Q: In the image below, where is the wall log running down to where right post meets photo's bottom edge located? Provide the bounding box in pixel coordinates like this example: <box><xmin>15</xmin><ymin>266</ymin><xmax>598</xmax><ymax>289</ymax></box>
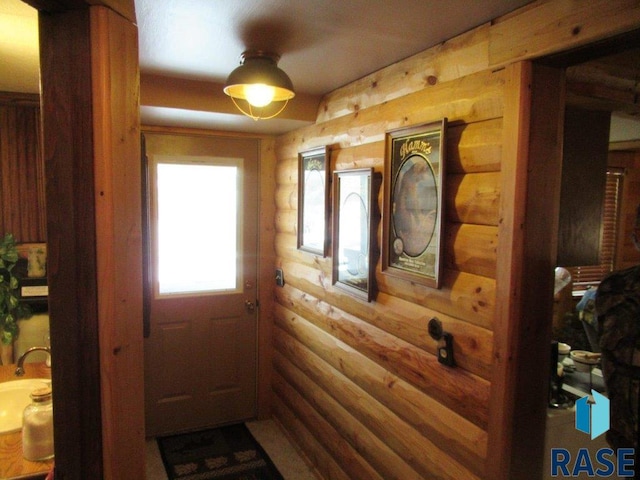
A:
<box><xmin>274</xmin><ymin>344</ymin><xmax>477</xmax><ymax>480</ymax></box>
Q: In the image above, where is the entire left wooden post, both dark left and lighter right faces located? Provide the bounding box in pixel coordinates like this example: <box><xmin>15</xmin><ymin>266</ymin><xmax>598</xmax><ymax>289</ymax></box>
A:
<box><xmin>39</xmin><ymin>2</ymin><xmax>145</xmax><ymax>479</ymax></box>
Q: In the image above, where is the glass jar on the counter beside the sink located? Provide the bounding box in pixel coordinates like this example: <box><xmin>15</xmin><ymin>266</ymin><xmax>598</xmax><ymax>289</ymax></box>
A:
<box><xmin>22</xmin><ymin>387</ymin><xmax>53</xmax><ymax>462</ymax></box>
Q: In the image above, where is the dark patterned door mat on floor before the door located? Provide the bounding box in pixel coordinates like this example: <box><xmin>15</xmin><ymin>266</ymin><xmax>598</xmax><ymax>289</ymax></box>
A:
<box><xmin>157</xmin><ymin>424</ymin><xmax>284</xmax><ymax>480</ymax></box>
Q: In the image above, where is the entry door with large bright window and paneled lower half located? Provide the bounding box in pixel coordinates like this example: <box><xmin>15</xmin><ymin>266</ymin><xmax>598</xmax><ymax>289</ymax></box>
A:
<box><xmin>144</xmin><ymin>133</ymin><xmax>259</xmax><ymax>436</ymax></box>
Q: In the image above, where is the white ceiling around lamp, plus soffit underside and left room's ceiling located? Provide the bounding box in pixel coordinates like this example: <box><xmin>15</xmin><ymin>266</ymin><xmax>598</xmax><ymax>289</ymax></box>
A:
<box><xmin>0</xmin><ymin>0</ymin><xmax>531</xmax><ymax>133</ymax></box>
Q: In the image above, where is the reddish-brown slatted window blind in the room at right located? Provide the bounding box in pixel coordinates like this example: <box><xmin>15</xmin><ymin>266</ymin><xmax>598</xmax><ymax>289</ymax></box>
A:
<box><xmin>567</xmin><ymin>167</ymin><xmax>624</xmax><ymax>293</ymax></box>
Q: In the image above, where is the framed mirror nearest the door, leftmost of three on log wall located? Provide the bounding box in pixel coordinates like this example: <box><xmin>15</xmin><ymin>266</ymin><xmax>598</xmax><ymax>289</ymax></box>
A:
<box><xmin>298</xmin><ymin>147</ymin><xmax>331</xmax><ymax>257</ymax></box>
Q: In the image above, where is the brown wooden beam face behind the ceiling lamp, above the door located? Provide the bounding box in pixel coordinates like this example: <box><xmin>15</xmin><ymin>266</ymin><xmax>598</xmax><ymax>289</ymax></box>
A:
<box><xmin>140</xmin><ymin>73</ymin><xmax>321</xmax><ymax>122</ymax></box>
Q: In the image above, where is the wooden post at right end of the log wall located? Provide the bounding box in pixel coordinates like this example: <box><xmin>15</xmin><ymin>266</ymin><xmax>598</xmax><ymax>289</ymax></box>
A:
<box><xmin>485</xmin><ymin>62</ymin><xmax>564</xmax><ymax>480</ymax></box>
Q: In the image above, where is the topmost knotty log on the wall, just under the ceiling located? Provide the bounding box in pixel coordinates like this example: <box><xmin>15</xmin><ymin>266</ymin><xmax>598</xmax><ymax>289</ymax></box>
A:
<box><xmin>317</xmin><ymin>25</ymin><xmax>488</xmax><ymax>123</ymax></box>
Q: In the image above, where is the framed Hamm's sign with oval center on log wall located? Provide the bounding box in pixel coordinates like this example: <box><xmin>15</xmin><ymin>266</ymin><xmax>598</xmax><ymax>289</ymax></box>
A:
<box><xmin>382</xmin><ymin>118</ymin><xmax>447</xmax><ymax>288</ymax></box>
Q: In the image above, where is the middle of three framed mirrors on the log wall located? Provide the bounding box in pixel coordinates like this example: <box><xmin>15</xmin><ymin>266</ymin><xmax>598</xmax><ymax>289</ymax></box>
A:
<box><xmin>332</xmin><ymin>168</ymin><xmax>379</xmax><ymax>302</ymax></box>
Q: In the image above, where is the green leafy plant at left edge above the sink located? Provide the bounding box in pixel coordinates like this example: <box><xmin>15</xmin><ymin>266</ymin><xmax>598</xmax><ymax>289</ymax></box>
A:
<box><xmin>0</xmin><ymin>233</ymin><xmax>31</xmax><ymax>364</ymax></box>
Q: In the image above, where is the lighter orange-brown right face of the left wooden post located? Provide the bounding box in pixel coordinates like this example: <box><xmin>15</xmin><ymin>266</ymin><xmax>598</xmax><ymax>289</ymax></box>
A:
<box><xmin>90</xmin><ymin>2</ymin><xmax>145</xmax><ymax>480</ymax></box>
